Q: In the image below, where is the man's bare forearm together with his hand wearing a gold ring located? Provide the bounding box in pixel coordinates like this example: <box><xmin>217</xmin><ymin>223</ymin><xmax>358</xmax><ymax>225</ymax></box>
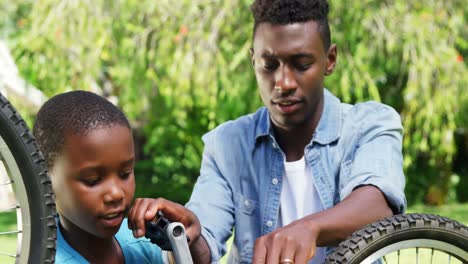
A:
<box><xmin>252</xmin><ymin>185</ymin><xmax>392</xmax><ymax>264</ymax></box>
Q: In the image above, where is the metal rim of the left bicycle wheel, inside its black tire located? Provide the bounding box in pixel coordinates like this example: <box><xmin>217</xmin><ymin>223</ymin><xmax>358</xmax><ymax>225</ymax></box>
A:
<box><xmin>0</xmin><ymin>136</ymin><xmax>31</xmax><ymax>263</ymax></box>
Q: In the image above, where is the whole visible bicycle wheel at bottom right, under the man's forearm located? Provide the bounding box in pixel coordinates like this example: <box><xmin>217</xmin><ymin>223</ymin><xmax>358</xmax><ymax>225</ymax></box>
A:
<box><xmin>326</xmin><ymin>214</ymin><xmax>468</xmax><ymax>264</ymax></box>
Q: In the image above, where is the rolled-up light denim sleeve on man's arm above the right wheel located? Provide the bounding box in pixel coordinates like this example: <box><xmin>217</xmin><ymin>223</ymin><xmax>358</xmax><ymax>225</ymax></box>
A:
<box><xmin>340</xmin><ymin>103</ymin><xmax>406</xmax><ymax>214</ymax></box>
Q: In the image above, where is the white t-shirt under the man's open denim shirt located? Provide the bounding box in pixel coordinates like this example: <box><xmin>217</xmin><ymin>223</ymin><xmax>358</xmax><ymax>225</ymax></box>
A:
<box><xmin>279</xmin><ymin>157</ymin><xmax>326</xmax><ymax>264</ymax></box>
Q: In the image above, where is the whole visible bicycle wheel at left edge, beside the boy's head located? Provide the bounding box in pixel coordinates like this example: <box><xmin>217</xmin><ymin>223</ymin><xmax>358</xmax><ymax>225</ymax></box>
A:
<box><xmin>0</xmin><ymin>93</ymin><xmax>56</xmax><ymax>263</ymax></box>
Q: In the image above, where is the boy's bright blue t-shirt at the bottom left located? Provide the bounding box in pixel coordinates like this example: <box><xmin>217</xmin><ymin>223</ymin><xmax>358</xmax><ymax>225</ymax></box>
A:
<box><xmin>55</xmin><ymin>219</ymin><xmax>164</xmax><ymax>264</ymax></box>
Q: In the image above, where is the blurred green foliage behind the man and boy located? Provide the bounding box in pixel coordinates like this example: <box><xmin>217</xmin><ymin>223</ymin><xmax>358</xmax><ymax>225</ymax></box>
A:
<box><xmin>0</xmin><ymin>0</ymin><xmax>468</xmax><ymax>205</ymax></box>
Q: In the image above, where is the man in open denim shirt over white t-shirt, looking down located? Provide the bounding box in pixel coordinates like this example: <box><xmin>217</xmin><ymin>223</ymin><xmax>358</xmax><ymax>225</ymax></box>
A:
<box><xmin>129</xmin><ymin>0</ymin><xmax>406</xmax><ymax>264</ymax></box>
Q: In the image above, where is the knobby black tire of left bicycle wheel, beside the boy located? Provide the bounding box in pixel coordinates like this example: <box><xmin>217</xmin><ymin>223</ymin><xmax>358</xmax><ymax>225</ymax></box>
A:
<box><xmin>0</xmin><ymin>93</ymin><xmax>57</xmax><ymax>263</ymax></box>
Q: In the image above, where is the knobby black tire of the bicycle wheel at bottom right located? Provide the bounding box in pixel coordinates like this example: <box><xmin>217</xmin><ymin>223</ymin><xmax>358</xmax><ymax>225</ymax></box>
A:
<box><xmin>325</xmin><ymin>213</ymin><xmax>468</xmax><ymax>264</ymax></box>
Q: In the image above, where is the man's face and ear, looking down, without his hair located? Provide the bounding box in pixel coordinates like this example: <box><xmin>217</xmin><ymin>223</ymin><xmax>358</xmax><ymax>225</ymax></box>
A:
<box><xmin>251</xmin><ymin>21</ymin><xmax>336</xmax><ymax>129</ymax></box>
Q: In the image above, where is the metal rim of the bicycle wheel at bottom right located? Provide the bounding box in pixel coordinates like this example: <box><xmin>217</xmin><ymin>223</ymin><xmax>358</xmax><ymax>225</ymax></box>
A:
<box><xmin>361</xmin><ymin>239</ymin><xmax>468</xmax><ymax>264</ymax></box>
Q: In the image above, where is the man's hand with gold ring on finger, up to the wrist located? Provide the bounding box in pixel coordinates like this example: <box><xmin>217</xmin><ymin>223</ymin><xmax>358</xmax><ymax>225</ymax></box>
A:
<box><xmin>252</xmin><ymin>218</ymin><xmax>319</xmax><ymax>264</ymax></box>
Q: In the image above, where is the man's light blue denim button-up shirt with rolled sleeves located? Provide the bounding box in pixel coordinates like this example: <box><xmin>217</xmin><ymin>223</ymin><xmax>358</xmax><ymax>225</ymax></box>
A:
<box><xmin>187</xmin><ymin>90</ymin><xmax>406</xmax><ymax>263</ymax></box>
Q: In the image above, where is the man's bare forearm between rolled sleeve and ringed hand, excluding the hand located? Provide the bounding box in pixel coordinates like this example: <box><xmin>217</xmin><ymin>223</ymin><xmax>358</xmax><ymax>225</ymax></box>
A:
<box><xmin>305</xmin><ymin>186</ymin><xmax>393</xmax><ymax>246</ymax></box>
